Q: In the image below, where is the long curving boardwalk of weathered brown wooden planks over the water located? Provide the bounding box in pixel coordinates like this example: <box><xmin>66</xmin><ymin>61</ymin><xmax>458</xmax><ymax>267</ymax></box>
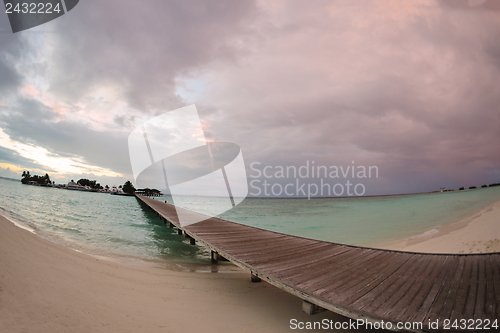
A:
<box><xmin>137</xmin><ymin>196</ymin><xmax>500</xmax><ymax>332</ymax></box>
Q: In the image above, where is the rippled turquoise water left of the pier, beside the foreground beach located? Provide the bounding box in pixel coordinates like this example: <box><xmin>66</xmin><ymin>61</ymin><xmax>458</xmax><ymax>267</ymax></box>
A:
<box><xmin>0</xmin><ymin>178</ymin><xmax>210</xmax><ymax>264</ymax></box>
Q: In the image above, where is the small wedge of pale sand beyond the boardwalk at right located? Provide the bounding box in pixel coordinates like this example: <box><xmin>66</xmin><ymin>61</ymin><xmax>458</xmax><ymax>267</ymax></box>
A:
<box><xmin>380</xmin><ymin>197</ymin><xmax>500</xmax><ymax>254</ymax></box>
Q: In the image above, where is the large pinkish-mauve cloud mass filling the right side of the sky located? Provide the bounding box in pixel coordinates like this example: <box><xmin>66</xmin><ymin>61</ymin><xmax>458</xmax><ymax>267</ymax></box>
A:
<box><xmin>194</xmin><ymin>2</ymin><xmax>500</xmax><ymax>190</ymax></box>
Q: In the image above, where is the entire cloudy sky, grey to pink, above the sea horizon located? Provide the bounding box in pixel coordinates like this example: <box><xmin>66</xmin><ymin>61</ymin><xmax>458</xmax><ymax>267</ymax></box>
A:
<box><xmin>0</xmin><ymin>0</ymin><xmax>500</xmax><ymax>194</ymax></box>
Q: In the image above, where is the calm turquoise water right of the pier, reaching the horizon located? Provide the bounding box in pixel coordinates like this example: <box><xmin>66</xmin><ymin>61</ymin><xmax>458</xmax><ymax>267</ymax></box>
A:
<box><xmin>170</xmin><ymin>187</ymin><xmax>500</xmax><ymax>247</ymax></box>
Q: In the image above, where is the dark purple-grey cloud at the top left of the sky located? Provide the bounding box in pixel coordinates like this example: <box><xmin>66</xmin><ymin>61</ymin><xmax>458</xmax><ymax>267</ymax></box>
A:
<box><xmin>46</xmin><ymin>0</ymin><xmax>256</xmax><ymax>111</ymax></box>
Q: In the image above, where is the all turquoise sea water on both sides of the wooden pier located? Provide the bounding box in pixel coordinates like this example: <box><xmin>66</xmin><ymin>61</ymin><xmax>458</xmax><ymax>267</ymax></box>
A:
<box><xmin>0</xmin><ymin>178</ymin><xmax>500</xmax><ymax>263</ymax></box>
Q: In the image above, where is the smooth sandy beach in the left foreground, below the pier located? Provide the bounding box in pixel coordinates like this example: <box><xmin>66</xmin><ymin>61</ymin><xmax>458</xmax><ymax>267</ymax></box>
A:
<box><xmin>0</xmin><ymin>216</ymin><xmax>348</xmax><ymax>333</ymax></box>
